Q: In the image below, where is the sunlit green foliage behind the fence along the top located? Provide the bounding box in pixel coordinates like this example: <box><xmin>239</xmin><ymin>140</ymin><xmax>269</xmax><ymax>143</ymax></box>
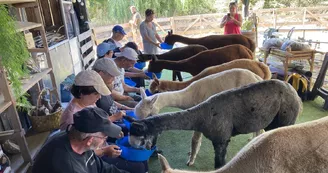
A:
<box><xmin>87</xmin><ymin>0</ymin><xmax>328</xmax><ymax>25</ymax></box>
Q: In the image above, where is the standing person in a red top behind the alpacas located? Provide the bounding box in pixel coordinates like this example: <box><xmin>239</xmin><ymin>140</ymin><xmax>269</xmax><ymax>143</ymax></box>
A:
<box><xmin>220</xmin><ymin>2</ymin><xmax>243</xmax><ymax>35</ymax></box>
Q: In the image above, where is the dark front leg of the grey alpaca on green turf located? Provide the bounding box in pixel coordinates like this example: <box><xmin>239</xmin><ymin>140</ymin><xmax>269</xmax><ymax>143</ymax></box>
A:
<box><xmin>212</xmin><ymin>140</ymin><xmax>229</xmax><ymax>169</ymax></box>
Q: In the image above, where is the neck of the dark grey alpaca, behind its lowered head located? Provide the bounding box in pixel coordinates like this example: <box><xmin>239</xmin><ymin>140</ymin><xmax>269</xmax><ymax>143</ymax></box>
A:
<box><xmin>140</xmin><ymin>110</ymin><xmax>200</xmax><ymax>135</ymax></box>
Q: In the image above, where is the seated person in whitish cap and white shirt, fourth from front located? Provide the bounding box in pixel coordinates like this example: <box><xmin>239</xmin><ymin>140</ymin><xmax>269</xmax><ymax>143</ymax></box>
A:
<box><xmin>112</xmin><ymin>47</ymin><xmax>146</xmax><ymax>108</ymax></box>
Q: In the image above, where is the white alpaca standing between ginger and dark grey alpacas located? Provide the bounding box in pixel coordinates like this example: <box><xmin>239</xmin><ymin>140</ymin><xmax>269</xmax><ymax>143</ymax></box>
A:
<box><xmin>135</xmin><ymin>68</ymin><xmax>263</xmax><ymax>166</ymax></box>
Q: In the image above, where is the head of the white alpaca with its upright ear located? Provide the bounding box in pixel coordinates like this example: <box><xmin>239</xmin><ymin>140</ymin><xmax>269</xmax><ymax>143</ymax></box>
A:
<box><xmin>134</xmin><ymin>88</ymin><xmax>158</xmax><ymax>119</ymax></box>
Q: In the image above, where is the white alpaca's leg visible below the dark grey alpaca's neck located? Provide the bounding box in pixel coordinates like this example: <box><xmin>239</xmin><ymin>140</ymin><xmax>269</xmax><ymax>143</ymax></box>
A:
<box><xmin>187</xmin><ymin>131</ymin><xmax>203</xmax><ymax>166</ymax></box>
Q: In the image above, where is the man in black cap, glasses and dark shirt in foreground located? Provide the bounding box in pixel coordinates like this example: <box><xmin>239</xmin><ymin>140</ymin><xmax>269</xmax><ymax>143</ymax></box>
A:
<box><xmin>32</xmin><ymin>107</ymin><xmax>127</xmax><ymax>173</ymax></box>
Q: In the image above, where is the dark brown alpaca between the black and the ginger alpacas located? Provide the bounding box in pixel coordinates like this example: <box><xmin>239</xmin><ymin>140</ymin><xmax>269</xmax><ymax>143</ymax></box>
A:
<box><xmin>148</xmin><ymin>44</ymin><xmax>253</xmax><ymax>76</ymax></box>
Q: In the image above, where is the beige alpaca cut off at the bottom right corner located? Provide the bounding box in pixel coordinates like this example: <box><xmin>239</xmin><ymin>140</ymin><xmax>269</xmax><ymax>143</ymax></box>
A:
<box><xmin>159</xmin><ymin>117</ymin><xmax>328</xmax><ymax>173</ymax></box>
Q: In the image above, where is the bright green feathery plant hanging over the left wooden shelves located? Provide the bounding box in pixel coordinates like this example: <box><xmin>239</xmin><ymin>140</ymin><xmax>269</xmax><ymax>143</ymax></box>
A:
<box><xmin>0</xmin><ymin>5</ymin><xmax>30</xmax><ymax>104</ymax></box>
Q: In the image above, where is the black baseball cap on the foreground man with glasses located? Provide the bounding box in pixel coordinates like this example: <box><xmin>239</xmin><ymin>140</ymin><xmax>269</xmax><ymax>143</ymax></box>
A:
<box><xmin>73</xmin><ymin>107</ymin><xmax>122</xmax><ymax>138</ymax></box>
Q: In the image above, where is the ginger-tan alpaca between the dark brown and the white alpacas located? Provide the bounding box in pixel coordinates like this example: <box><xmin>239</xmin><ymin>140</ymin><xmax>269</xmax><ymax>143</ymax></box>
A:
<box><xmin>149</xmin><ymin>59</ymin><xmax>271</xmax><ymax>93</ymax></box>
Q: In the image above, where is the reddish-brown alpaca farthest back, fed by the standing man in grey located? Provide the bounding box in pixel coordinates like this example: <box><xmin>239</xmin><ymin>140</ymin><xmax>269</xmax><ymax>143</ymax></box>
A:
<box><xmin>164</xmin><ymin>32</ymin><xmax>256</xmax><ymax>52</ymax></box>
